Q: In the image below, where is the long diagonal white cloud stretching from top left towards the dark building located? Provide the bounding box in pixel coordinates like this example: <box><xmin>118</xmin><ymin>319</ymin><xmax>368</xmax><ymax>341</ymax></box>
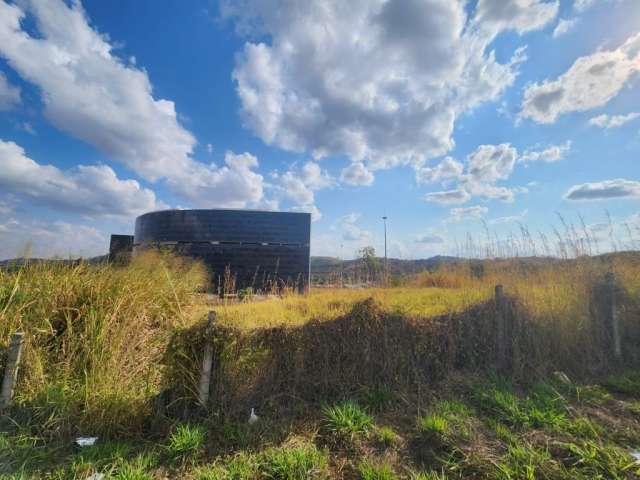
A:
<box><xmin>0</xmin><ymin>0</ymin><xmax>262</xmax><ymax>207</ymax></box>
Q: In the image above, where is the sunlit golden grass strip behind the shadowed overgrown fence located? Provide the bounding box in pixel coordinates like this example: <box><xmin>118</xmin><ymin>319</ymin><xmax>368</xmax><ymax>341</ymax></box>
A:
<box><xmin>210</xmin><ymin>256</ymin><xmax>640</xmax><ymax>329</ymax></box>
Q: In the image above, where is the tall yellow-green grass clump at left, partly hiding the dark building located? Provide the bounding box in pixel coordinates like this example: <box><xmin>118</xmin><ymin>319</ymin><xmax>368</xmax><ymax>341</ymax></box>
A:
<box><xmin>0</xmin><ymin>252</ymin><xmax>206</xmax><ymax>434</ymax></box>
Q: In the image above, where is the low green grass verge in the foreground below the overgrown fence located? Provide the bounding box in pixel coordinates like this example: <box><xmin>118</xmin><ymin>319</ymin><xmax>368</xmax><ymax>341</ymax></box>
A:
<box><xmin>0</xmin><ymin>371</ymin><xmax>640</xmax><ymax>480</ymax></box>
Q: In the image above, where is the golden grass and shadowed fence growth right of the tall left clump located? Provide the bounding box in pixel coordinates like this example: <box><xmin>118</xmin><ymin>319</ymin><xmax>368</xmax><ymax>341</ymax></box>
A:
<box><xmin>165</xmin><ymin>254</ymin><xmax>640</xmax><ymax>411</ymax></box>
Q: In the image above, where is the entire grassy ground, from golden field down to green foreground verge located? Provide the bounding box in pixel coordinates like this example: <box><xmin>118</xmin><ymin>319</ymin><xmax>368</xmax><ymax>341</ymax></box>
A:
<box><xmin>0</xmin><ymin>254</ymin><xmax>640</xmax><ymax>480</ymax></box>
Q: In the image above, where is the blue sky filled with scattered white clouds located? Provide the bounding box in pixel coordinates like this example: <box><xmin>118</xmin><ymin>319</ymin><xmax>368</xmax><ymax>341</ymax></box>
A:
<box><xmin>0</xmin><ymin>0</ymin><xmax>640</xmax><ymax>258</ymax></box>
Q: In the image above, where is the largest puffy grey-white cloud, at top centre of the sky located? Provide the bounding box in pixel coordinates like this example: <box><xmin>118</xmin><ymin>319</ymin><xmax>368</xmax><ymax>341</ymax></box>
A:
<box><xmin>228</xmin><ymin>0</ymin><xmax>557</xmax><ymax>171</ymax></box>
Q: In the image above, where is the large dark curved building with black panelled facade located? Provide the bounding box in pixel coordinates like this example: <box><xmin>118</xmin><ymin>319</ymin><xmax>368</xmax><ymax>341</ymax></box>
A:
<box><xmin>133</xmin><ymin>210</ymin><xmax>311</xmax><ymax>290</ymax></box>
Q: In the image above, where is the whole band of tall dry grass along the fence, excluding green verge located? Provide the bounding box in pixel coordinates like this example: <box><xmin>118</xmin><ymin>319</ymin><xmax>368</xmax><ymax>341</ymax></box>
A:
<box><xmin>0</xmin><ymin>242</ymin><xmax>640</xmax><ymax>435</ymax></box>
